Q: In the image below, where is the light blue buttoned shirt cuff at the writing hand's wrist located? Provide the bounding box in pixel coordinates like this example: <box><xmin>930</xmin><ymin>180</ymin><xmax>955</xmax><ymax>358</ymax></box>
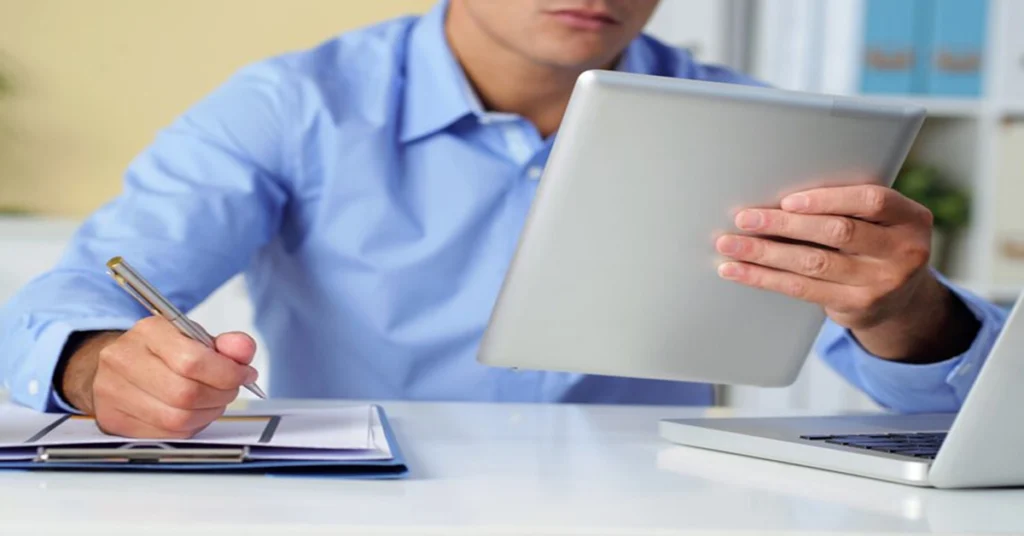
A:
<box><xmin>6</xmin><ymin>317</ymin><xmax>138</xmax><ymax>413</ymax></box>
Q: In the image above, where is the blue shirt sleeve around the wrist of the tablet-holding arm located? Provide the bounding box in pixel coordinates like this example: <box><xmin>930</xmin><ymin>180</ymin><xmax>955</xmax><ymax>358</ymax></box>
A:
<box><xmin>815</xmin><ymin>273</ymin><xmax>1008</xmax><ymax>413</ymax></box>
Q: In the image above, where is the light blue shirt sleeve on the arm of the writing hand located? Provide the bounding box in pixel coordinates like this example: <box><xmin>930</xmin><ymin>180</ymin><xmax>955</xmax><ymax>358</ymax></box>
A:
<box><xmin>0</xmin><ymin>61</ymin><xmax>295</xmax><ymax>411</ymax></box>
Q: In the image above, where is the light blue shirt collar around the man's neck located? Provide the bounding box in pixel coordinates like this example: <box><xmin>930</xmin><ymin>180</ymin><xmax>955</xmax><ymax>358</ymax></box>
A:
<box><xmin>399</xmin><ymin>0</ymin><xmax>653</xmax><ymax>143</ymax></box>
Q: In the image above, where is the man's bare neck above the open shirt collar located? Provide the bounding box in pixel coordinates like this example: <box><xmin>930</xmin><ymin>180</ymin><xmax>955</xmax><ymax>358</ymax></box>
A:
<box><xmin>444</xmin><ymin>2</ymin><xmax>602</xmax><ymax>137</ymax></box>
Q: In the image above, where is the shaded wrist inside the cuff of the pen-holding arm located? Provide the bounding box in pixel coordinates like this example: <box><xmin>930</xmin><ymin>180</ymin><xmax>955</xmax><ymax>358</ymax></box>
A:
<box><xmin>53</xmin><ymin>331</ymin><xmax>121</xmax><ymax>414</ymax></box>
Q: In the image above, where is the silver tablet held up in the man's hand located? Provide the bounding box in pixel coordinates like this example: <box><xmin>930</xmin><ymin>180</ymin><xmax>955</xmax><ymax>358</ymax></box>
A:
<box><xmin>477</xmin><ymin>71</ymin><xmax>926</xmax><ymax>386</ymax></box>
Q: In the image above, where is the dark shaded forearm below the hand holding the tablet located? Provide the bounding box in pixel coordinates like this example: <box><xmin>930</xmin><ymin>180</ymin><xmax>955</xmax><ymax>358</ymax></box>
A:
<box><xmin>853</xmin><ymin>278</ymin><xmax>981</xmax><ymax>365</ymax></box>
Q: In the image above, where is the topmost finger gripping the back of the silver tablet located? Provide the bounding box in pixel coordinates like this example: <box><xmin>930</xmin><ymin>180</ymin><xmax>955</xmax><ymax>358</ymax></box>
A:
<box><xmin>781</xmin><ymin>184</ymin><xmax>931</xmax><ymax>224</ymax></box>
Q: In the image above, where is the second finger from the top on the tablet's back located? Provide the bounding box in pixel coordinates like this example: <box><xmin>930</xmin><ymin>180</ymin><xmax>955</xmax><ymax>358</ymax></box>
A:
<box><xmin>735</xmin><ymin>209</ymin><xmax>892</xmax><ymax>256</ymax></box>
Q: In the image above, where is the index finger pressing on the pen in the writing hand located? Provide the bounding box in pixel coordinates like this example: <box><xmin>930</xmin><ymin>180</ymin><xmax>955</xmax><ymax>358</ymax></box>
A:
<box><xmin>135</xmin><ymin>317</ymin><xmax>257</xmax><ymax>390</ymax></box>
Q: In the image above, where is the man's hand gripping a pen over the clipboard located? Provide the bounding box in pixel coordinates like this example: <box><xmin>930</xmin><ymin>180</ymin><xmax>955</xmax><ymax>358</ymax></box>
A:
<box><xmin>60</xmin><ymin>317</ymin><xmax>257</xmax><ymax>439</ymax></box>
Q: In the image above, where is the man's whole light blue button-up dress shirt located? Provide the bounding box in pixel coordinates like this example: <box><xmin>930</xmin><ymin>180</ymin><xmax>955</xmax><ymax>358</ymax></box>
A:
<box><xmin>0</xmin><ymin>3</ymin><xmax>1004</xmax><ymax>411</ymax></box>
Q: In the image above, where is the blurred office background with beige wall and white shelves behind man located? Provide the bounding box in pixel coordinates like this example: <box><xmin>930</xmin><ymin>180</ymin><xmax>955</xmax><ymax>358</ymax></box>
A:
<box><xmin>0</xmin><ymin>0</ymin><xmax>1024</xmax><ymax>411</ymax></box>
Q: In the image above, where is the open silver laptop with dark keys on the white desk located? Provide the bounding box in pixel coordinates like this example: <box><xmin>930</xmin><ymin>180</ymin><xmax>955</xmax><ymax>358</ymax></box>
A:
<box><xmin>660</xmin><ymin>295</ymin><xmax>1024</xmax><ymax>488</ymax></box>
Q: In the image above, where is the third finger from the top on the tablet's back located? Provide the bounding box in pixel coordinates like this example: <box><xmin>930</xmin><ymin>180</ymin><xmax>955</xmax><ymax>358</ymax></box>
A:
<box><xmin>715</xmin><ymin>235</ymin><xmax>871</xmax><ymax>285</ymax></box>
